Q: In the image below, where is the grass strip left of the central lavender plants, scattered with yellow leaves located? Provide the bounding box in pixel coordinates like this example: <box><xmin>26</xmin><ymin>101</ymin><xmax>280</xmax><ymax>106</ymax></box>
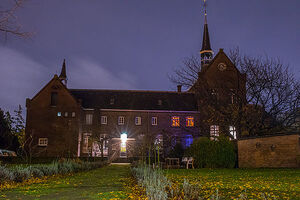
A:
<box><xmin>0</xmin><ymin>166</ymin><xmax>131</xmax><ymax>200</ymax></box>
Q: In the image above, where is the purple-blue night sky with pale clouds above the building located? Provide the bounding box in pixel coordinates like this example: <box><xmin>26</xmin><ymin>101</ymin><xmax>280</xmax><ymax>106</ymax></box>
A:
<box><xmin>0</xmin><ymin>0</ymin><xmax>300</xmax><ymax>110</ymax></box>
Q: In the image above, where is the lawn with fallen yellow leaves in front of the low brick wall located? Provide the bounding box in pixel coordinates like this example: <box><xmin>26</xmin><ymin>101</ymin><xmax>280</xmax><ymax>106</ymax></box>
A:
<box><xmin>164</xmin><ymin>169</ymin><xmax>300</xmax><ymax>199</ymax></box>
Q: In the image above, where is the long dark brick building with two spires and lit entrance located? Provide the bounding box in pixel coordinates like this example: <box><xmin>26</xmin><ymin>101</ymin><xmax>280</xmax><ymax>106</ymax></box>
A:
<box><xmin>26</xmin><ymin>10</ymin><xmax>245</xmax><ymax>160</ymax></box>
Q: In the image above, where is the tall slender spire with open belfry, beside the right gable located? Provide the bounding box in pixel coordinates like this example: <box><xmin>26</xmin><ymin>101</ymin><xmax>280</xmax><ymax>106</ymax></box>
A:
<box><xmin>200</xmin><ymin>0</ymin><xmax>214</xmax><ymax>70</ymax></box>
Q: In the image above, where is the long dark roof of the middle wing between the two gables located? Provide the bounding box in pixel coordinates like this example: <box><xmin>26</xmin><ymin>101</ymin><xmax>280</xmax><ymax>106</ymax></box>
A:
<box><xmin>69</xmin><ymin>89</ymin><xmax>197</xmax><ymax>111</ymax></box>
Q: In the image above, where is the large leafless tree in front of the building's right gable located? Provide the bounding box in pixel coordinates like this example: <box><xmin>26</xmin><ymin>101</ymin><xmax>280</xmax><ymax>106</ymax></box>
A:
<box><xmin>170</xmin><ymin>48</ymin><xmax>300</xmax><ymax>135</ymax></box>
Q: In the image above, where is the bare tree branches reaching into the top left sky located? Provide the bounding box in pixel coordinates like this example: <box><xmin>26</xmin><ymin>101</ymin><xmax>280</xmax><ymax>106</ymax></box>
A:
<box><xmin>0</xmin><ymin>0</ymin><xmax>31</xmax><ymax>38</ymax></box>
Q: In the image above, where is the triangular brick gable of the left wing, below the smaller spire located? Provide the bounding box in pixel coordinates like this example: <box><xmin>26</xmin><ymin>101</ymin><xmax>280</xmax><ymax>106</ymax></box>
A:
<box><xmin>30</xmin><ymin>75</ymin><xmax>77</xmax><ymax>108</ymax></box>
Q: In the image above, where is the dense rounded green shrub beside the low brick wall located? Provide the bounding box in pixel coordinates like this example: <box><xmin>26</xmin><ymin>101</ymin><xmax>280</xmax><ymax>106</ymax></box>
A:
<box><xmin>186</xmin><ymin>137</ymin><xmax>236</xmax><ymax>168</ymax></box>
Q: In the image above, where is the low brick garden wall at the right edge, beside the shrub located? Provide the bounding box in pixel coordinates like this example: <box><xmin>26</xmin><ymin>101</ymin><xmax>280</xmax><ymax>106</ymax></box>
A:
<box><xmin>238</xmin><ymin>134</ymin><xmax>300</xmax><ymax>168</ymax></box>
